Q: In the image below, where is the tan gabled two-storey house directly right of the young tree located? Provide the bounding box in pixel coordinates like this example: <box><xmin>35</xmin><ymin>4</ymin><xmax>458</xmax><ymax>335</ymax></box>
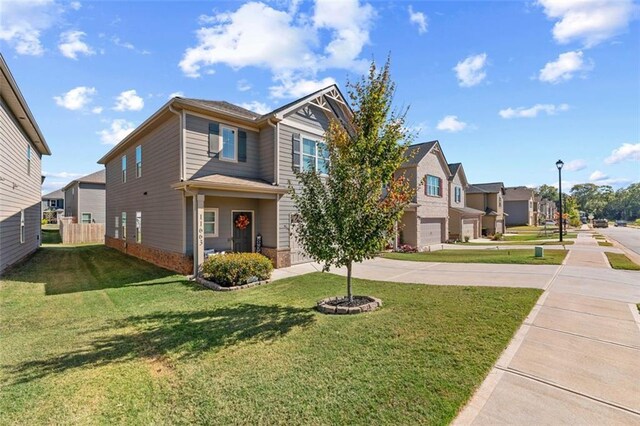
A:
<box><xmin>396</xmin><ymin>141</ymin><xmax>451</xmax><ymax>246</ymax></box>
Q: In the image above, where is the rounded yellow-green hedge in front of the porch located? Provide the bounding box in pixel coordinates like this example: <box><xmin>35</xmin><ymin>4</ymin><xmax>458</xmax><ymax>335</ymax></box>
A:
<box><xmin>202</xmin><ymin>253</ymin><xmax>273</xmax><ymax>287</ymax></box>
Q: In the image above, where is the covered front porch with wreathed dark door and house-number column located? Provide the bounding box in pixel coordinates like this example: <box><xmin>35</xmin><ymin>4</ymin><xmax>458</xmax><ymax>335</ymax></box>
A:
<box><xmin>175</xmin><ymin>175</ymin><xmax>287</xmax><ymax>273</ymax></box>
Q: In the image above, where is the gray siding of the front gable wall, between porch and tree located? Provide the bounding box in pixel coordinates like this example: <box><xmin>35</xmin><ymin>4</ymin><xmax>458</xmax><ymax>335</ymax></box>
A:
<box><xmin>278</xmin><ymin>107</ymin><xmax>329</xmax><ymax>248</ymax></box>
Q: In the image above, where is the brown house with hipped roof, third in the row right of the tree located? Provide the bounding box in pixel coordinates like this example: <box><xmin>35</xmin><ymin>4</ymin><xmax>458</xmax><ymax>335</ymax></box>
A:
<box><xmin>466</xmin><ymin>182</ymin><xmax>505</xmax><ymax>235</ymax></box>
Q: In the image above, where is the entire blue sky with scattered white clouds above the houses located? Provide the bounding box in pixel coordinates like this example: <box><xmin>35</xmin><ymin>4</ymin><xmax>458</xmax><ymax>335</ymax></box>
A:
<box><xmin>0</xmin><ymin>0</ymin><xmax>640</xmax><ymax>193</ymax></box>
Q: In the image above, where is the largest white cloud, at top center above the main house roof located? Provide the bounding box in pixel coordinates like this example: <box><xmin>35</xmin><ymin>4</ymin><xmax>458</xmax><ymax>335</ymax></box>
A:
<box><xmin>179</xmin><ymin>0</ymin><xmax>375</xmax><ymax>97</ymax></box>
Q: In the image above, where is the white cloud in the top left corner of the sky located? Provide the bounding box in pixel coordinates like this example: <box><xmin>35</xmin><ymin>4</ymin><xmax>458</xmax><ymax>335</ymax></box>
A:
<box><xmin>0</xmin><ymin>0</ymin><xmax>62</xmax><ymax>56</ymax></box>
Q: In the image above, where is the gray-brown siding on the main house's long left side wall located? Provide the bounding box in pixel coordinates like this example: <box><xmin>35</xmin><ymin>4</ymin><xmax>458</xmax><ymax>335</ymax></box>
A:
<box><xmin>106</xmin><ymin>114</ymin><xmax>185</xmax><ymax>253</ymax></box>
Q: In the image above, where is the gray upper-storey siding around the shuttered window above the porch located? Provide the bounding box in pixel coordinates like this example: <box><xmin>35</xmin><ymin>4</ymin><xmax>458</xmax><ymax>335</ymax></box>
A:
<box><xmin>185</xmin><ymin>114</ymin><xmax>261</xmax><ymax>179</ymax></box>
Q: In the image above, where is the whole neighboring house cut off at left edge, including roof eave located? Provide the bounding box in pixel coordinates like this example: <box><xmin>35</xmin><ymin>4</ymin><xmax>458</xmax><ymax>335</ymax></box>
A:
<box><xmin>0</xmin><ymin>55</ymin><xmax>51</xmax><ymax>274</ymax></box>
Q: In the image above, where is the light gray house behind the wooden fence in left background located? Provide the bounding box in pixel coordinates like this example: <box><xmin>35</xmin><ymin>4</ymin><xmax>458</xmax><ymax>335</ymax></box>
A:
<box><xmin>62</xmin><ymin>169</ymin><xmax>106</xmax><ymax>223</ymax></box>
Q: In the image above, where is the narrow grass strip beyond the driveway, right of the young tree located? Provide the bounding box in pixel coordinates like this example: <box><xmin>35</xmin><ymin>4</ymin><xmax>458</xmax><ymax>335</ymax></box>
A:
<box><xmin>381</xmin><ymin>248</ymin><xmax>567</xmax><ymax>265</ymax></box>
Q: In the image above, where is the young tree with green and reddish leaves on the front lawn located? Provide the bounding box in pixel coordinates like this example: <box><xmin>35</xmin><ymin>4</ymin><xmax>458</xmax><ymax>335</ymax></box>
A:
<box><xmin>291</xmin><ymin>61</ymin><xmax>415</xmax><ymax>303</ymax></box>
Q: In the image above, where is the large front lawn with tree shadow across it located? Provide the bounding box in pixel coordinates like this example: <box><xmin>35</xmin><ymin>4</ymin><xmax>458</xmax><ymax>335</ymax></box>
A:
<box><xmin>0</xmin><ymin>246</ymin><xmax>541</xmax><ymax>425</ymax></box>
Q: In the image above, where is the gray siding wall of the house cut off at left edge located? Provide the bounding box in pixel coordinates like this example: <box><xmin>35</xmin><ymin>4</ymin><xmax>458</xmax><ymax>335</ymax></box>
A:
<box><xmin>0</xmin><ymin>98</ymin><xmax>42</xmax><ymax>273</ymax></box>
